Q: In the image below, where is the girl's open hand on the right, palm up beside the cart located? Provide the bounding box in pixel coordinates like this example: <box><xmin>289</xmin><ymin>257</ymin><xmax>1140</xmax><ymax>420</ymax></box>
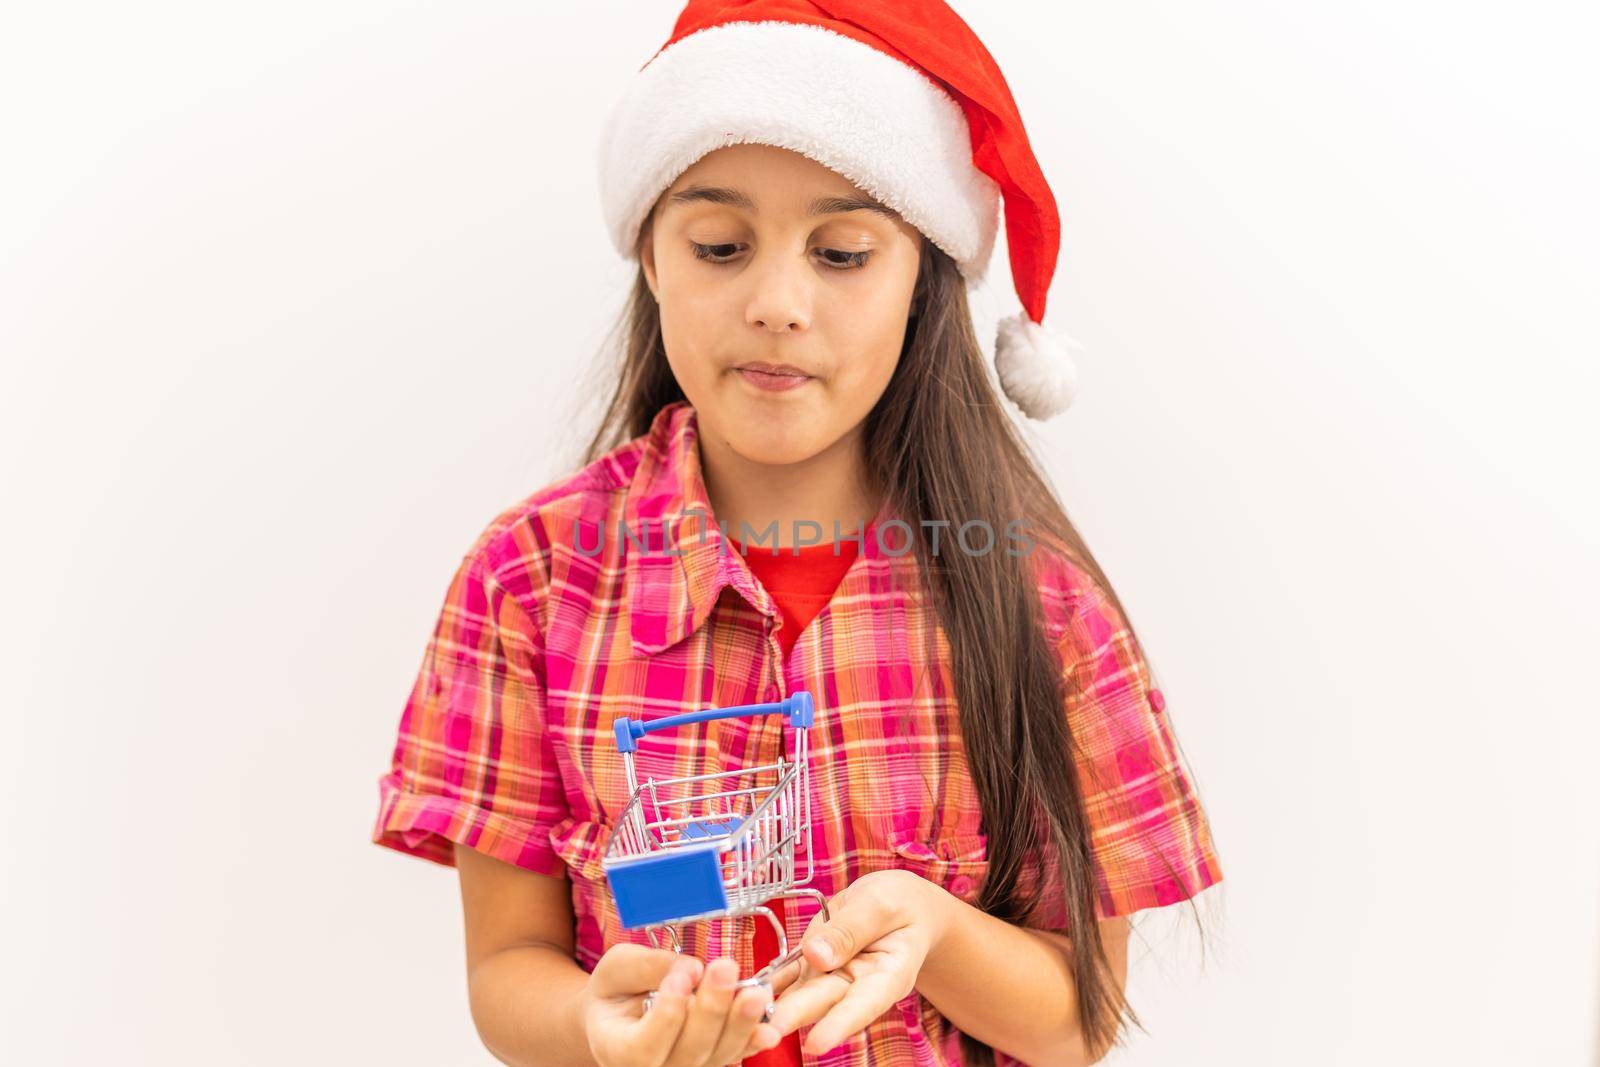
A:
<box><xmin>748</xmin><ymin>870</ymin><xmax>954</xmax><ymax>1056</ymax></box>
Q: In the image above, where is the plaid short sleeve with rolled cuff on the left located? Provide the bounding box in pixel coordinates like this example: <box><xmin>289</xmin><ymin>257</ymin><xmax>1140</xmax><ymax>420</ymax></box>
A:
<box><xmin>371</xmin><ymin>553</ymin><xmax>568</xmax><ymax>875</ymax></box>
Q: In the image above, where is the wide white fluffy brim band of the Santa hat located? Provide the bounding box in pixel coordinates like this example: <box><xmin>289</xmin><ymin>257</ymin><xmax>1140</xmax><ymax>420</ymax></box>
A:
<box><xmin>598</xmin><ymin>21</ymin><xmax>1000</xmax><ymax>285</ymax></box>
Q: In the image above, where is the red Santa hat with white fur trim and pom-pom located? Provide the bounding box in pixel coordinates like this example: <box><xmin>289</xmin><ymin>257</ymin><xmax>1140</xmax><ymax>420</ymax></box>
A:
<box><xmin>600</xmin><ymin>0</ymin><xmax>1082</xmax><ymax>419</ymax></box>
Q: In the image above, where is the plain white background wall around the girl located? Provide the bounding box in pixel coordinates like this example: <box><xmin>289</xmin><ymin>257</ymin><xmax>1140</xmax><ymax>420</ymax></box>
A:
<box><xmin>0</xmin><ymin>0</ymin><xmax>1600</xmax><ymax>1065</ymax></box>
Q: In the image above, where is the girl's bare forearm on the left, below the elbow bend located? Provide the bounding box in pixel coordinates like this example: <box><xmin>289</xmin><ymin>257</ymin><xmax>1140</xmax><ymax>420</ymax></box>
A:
<box><xmin>467</xmin><ymin>945</ymin><xmax>597</xmax><ymax>1067</ymax></box>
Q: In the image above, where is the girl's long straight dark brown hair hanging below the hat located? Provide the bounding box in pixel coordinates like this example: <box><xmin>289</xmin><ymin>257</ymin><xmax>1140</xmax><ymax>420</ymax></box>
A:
<box><xmin>569</xmin><ymin>218</ymin><xmax>1158</xmax><ymax>1067</ymax></box>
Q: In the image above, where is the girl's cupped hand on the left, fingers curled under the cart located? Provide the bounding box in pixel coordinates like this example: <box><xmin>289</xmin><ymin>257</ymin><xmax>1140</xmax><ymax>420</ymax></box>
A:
<box><xmin>581</xmin><ymin>942</ymin><xmax>779</xmax><ymax>1067</ymax></box>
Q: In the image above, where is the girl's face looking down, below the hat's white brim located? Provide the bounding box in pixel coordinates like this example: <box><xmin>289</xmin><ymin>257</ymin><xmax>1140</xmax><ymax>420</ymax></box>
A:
<box><xmin>640</xmin><ymin>144</ymin><xmax>923</xmax><ymax>464</ymax></box>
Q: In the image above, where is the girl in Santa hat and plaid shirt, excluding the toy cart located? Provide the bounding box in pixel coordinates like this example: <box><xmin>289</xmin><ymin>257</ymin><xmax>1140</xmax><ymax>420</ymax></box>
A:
<box><xmin>373</xmin><ymin>0</ymin><xmax>1221</xmax><ymax>1067</ymax></box>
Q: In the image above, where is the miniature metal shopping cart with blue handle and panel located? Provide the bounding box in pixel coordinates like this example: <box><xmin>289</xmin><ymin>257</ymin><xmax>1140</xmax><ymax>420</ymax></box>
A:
<box><xmin>602</xmin><ymin>691</ymin><xmax>827</xmax><ymax>1009</ymax></box>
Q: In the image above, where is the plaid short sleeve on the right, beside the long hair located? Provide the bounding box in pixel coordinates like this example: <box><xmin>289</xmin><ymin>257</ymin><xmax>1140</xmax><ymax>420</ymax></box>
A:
<box><xmin>1040</xmin><ymin>585</ymin><xmax>1222</xmax><ymax>928</ymax></box>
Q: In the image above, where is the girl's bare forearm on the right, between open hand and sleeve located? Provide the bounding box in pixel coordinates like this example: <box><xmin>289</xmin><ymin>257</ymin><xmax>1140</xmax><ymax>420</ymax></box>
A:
<box><xmin>917</xmin><ymin>889</ymin><xmax>1094</xmax><ymax>1067</ymax></box>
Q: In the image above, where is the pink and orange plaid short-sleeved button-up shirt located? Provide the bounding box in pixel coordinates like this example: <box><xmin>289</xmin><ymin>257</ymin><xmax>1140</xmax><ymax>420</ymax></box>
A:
<box><xmin>371</xmin><ymin>402</ymin><xmax>1221</xmax><ymax>1067</ymax></box>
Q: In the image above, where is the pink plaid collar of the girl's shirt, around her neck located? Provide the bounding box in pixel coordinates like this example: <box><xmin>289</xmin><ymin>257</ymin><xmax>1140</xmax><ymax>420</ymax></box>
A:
<box><xmin>616</xmin><ymin>400</ymin><xmax>910</xmax><ymax>656</ymax></box>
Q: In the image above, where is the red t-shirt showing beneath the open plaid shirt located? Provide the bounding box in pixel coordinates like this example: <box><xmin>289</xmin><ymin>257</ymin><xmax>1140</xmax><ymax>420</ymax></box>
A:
<box><xmin>744</xmin><ymin>541</ymin><xmax>858</xmax><ymax>1067</ymax></box>
